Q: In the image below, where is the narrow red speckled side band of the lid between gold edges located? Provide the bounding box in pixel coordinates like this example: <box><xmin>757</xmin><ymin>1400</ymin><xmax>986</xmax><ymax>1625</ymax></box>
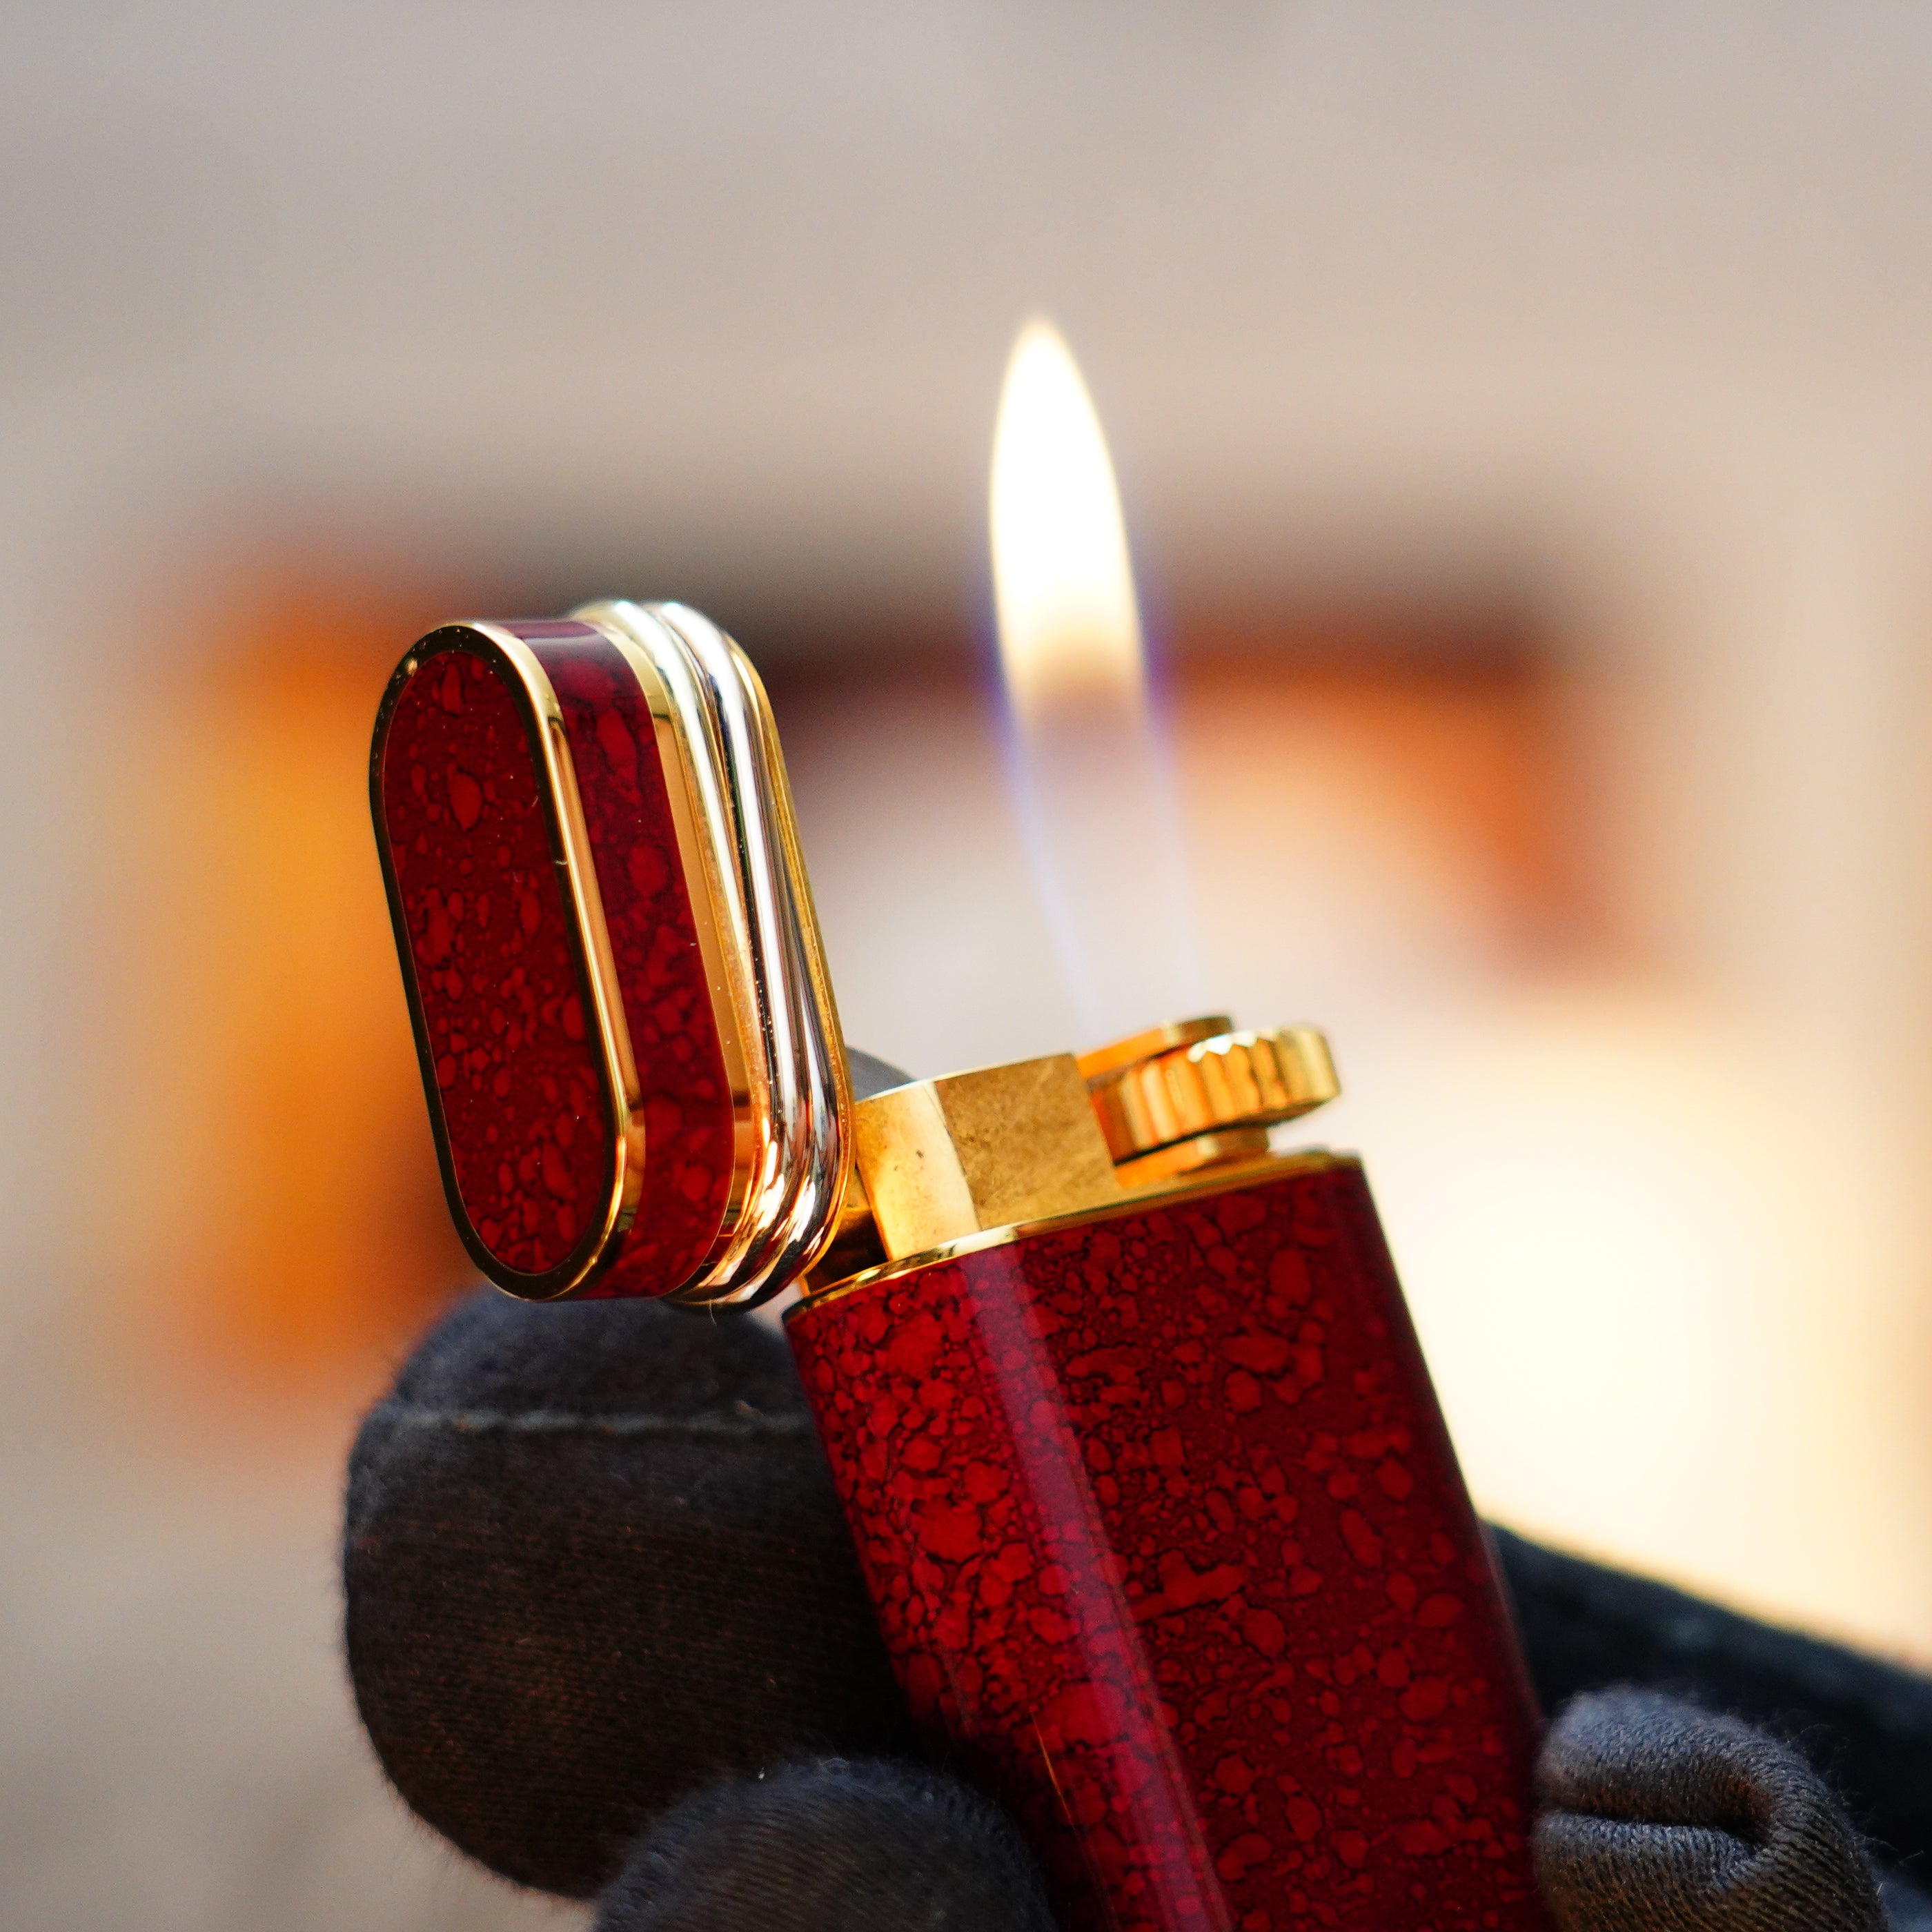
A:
<box><xmin>508</xmin><ymin>622</ymin><xmax>732</xmax><ymax>1294</ymax></box>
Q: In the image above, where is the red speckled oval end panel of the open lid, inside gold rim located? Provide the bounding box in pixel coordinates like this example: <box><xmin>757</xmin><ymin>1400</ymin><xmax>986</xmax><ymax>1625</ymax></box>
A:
<box><xmin>382</xmin><ymin>651</ymin><xmax>614</xmax><ymax>1275</ymax></box>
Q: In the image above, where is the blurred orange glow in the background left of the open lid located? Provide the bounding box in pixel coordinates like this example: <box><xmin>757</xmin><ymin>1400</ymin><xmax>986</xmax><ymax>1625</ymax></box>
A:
<box><xmin>106</xmin><ymin>558</ymin><xmax>468</xmax><ymax>1447</ymax></box>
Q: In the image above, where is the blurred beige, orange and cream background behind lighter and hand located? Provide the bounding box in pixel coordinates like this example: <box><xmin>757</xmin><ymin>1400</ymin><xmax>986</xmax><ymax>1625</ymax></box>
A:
<box><xmin>11</xmin><ymin>0</ymin><xmax>1932</xmax><ymax>1932</ymax></box>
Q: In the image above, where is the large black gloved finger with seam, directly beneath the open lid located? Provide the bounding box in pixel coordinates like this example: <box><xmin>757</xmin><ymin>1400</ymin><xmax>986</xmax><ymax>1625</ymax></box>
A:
<box><xmin>342</xmin><ymin>1051</ymin><xmax>908</xmax><ymax>1897</ymax></box>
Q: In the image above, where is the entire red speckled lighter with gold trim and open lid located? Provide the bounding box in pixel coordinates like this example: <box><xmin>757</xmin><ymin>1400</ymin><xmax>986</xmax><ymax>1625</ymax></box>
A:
<box><xmin>369</xmin><ymin>603</ymin><xmax>1544</xmax><ymax>1932</ymax></box>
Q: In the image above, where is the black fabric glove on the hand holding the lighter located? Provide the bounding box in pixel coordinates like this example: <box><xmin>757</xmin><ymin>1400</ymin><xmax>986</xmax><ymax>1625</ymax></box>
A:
<box><xmin>344</xmin><ymin>1292</ymin><xmax>1932</xmax><ymax>1932</ymax></box>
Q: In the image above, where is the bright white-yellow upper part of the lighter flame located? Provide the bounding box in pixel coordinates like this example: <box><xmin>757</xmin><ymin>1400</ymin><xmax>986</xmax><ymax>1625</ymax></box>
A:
<box><xmin>991</xmin><ymin>321</ymin><xmax>1145</xmax><ymax>727</ymax></box>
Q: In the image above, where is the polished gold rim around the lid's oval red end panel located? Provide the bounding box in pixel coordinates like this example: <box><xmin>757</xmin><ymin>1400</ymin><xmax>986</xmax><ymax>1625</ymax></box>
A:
<box><xmin>369</xmin><ymin>620</ymin><xmax>643</xmax><ymax>1300</ymax></box>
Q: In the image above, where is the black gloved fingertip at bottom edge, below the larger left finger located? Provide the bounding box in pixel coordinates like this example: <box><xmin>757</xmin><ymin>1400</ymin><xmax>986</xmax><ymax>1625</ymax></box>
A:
<box><xmin>591</xmin><ymin>1760</ymin><xmax>1053</xmax><ymax>1932</ymax></box>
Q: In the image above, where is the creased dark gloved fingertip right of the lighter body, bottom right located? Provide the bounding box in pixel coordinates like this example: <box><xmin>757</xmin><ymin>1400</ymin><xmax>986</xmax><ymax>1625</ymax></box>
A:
<box><xmin>1534</xmin><ymin>1690</ymin><xmax>1886</xmax><ymax>1932</ymax></box>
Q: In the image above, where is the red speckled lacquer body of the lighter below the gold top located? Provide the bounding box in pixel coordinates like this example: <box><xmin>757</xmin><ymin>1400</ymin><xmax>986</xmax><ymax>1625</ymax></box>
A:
<box><xmin>790</xmin><ymin>1161</ymin><xmax>1546</xmax><ymax>1932</ymax></box>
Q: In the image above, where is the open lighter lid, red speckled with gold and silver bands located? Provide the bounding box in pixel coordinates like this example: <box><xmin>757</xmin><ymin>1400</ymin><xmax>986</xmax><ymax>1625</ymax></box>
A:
<box><xmin>369</xmin><ymin>603</ymin><xmax>850</xmax><ymax>1302</ymax></box>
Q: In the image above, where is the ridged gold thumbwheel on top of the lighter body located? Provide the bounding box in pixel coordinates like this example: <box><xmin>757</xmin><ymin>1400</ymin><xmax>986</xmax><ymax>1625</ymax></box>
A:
<box><xmin>1080</xmin><ymin>1012</ymin><xmax>1341</xmax><ymax>1184</ymax></box>
